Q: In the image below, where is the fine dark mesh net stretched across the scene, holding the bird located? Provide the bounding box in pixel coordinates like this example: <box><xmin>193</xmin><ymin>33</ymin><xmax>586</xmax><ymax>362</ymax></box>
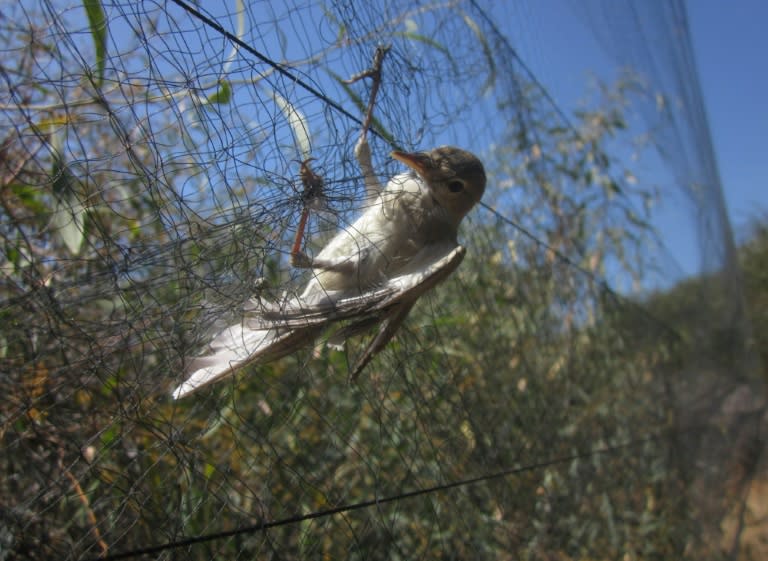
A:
<box><xmin>0</xmin><ymin>0</ymin><xmax>765</xmax><ymax>559</ymax></box>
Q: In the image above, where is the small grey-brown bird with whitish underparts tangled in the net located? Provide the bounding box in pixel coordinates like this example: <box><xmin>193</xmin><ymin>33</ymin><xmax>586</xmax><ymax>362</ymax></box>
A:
<box><xmin>172</xmin><ymin>142</ymin><xmax>486</xmax><ymax>399</ymax></box>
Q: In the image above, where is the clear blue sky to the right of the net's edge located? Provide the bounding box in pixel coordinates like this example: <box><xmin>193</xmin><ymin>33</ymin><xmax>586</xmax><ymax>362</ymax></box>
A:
<box><xmin>687</xmin><ymin>0</ymin><xmax>768</xmax><ymax>235</ymax></box>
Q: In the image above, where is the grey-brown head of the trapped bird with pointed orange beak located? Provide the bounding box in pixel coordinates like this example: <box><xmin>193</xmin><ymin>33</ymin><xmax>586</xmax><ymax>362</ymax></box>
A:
<box><xmin>392</xmin><ymin>146</ymin><xmax>486</xmax><ymax>224</ymax></box>
